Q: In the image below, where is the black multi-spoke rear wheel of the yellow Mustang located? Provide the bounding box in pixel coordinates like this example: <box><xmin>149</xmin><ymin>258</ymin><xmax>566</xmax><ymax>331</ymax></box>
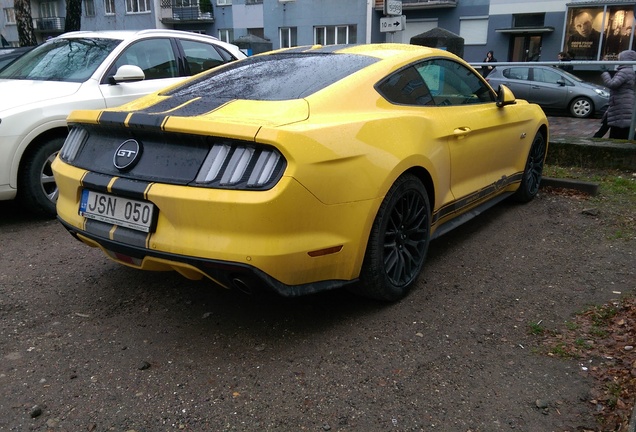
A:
<box><xmin>353</xmin><ymin>174</ymin><xmax>431</xmax><ymax>301</ymax></box>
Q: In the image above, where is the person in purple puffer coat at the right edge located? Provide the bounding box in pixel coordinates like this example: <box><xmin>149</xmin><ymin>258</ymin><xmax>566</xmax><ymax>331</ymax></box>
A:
<box><xmin>601</xmin><ymin>50</ymin><xmax>636</xmax><ymax>139</ymax></box>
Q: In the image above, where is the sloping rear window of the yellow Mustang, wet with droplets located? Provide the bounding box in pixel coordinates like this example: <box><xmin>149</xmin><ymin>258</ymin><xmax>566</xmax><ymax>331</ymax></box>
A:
<box><xmin>164</xmin><ymin>52</ymin><xmax>378</xmax><ymax>101</ymax></box>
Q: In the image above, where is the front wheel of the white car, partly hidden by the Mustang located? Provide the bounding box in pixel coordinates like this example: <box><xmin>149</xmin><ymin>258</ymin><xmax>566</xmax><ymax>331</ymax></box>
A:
<box><xmin>18</xmin><ymin>138</ymin><xmax>64</xmax><ymax>218</ymax></box>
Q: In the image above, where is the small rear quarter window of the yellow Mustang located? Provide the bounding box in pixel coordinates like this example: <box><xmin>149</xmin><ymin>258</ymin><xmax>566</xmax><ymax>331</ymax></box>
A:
<box><xmin>377</xmin><ymin>66</ymin><xmax>434</xmax><ymax>105</ymax></box>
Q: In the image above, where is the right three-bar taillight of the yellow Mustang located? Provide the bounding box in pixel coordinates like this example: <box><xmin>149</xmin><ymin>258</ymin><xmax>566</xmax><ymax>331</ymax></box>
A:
<box><xmin>195</xmin><ymin>142</ymin><xmax>286</xmax><ymax>189</ymax></box>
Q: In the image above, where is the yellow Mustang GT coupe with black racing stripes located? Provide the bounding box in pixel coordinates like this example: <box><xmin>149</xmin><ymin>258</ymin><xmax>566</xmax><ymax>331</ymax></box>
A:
<box><xmin>53</xmin><ymin>44</ymin><xmax>548</xmax><ymax>301</ymax></box>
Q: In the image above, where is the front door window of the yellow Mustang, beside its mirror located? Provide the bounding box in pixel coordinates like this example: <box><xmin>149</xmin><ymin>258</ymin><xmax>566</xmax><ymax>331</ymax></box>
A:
<box><xmin>415</xmin><ymin>59</ymin><xmax>495</xmax><ymax>106</ymax></box>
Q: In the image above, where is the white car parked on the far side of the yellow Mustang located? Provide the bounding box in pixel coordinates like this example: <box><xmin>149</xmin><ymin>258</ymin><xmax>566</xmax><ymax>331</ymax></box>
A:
<box><xmin>0</xmin><ymin>29</ymin><xmax>245</xmax><ymax>216</ymax></box>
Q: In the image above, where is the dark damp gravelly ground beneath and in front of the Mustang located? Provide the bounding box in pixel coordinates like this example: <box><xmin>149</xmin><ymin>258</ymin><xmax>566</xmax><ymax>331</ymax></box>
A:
<box><xmin>0</xmin><ymin>187</ymin><xmax>636</xmax><ymax>432</ymax></box>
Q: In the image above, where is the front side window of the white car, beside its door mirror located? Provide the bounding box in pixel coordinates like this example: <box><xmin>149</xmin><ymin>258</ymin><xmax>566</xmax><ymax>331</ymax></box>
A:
<box><xmin>108</xmin><ymin>39</ymin><xmax>179</xmax><ymax>80</ymax></box>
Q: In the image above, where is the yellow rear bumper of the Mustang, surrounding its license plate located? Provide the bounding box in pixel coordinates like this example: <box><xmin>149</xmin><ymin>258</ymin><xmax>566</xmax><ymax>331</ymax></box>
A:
<box><xmin>54</xmin><ymin>159</ymin><xmax>379</xmax><ymax>296</ymax></box>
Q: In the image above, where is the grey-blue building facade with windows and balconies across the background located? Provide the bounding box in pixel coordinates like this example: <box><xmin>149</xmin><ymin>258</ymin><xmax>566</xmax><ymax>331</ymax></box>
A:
<box><xmin>0</xmin><ymin>0</ymin><xmax>636</xmax><ymax>62</ymax></box>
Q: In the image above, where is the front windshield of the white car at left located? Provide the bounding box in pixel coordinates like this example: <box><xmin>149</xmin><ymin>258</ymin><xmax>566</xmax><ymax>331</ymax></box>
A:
<box><xmin>0</xmin><ymin>38</ymin><xmax>121</xmax><ymax>82</ymax></box>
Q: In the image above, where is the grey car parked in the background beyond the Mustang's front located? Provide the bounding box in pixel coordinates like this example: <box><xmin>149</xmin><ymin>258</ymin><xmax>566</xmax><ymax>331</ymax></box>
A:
<box><xmin>487</xmin><ymin>65</ymin><xmax>609</xmax><ymax>118</ymax></box>
